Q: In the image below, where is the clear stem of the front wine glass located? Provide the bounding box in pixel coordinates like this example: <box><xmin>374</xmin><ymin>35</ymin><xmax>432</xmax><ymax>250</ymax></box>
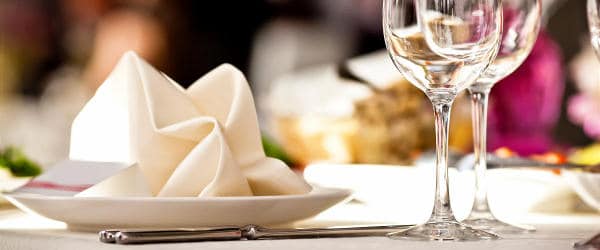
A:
<box><xmin>430</xmin><ymin>96</ymin><xmax>455</xmax><ymax>222</ymax></box>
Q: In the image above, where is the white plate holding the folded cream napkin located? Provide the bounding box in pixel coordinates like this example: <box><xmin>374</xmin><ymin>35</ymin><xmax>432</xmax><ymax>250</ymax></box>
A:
<box><xmin>5</xmin><ymin>188</ymin><xmax>350</xmax><ymax>231</ymax></box>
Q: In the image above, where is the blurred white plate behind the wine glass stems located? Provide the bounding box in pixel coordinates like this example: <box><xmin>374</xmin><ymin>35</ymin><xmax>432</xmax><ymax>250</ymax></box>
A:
<box><xmin>304</xmin><ymin>163</ymin><xmax>577</xmax><ymax>222</ymax></box>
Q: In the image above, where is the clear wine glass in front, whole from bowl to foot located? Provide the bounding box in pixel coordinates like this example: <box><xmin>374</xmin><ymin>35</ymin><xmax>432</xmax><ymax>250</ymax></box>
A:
<box><xmin>383</xmin><ymin>0</ymin><xmax>502</xmax><ymax>240</ymax></box>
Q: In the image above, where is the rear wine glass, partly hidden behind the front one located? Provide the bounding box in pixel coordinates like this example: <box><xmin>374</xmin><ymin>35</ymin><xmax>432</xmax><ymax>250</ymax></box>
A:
<box><xmin>462</xmin><ymin>0</ymin><xmax>541</xmax><ymax>233</ymax></box>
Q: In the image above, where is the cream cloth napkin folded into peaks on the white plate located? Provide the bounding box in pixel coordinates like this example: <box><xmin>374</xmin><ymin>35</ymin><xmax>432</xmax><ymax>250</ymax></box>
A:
<box><xmin>70</xmin><ymin>52</ymin><xmax>311</xmax><ymax>197</ymax></box>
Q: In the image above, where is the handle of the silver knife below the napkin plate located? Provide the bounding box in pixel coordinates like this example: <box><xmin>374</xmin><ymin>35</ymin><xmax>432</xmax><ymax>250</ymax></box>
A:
<box><xmin>114</xmin><ymin>228</ymin><xmax>242</xmax><ymax>244</ymax></box>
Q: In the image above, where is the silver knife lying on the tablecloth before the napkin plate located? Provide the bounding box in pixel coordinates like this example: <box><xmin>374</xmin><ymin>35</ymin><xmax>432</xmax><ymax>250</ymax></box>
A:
<box><xmin>100</xmin><ymin>225</ymin><xmax>412</xmax><ymax>244</ymax></box>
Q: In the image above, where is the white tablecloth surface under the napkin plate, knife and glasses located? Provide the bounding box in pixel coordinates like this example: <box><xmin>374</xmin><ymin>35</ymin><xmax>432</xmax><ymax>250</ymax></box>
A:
<box><xmin>0</xmin><ymin>205</ymin><xmax>600</xmax><ymax>250</ymax></box>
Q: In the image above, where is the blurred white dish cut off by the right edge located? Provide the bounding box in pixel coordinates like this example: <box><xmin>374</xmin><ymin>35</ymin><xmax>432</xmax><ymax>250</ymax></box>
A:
<box><xmin>562</xmin><ymin>170</ymin><xmax>600</xmax><ymax>211</ymax></box>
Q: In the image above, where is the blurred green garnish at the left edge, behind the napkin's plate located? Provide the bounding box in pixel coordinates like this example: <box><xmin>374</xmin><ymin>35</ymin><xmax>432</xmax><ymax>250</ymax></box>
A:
<box><xmin>0</xmin><ymin>147</ymin><xmax>42</xmax><ymax>177</ymax></box>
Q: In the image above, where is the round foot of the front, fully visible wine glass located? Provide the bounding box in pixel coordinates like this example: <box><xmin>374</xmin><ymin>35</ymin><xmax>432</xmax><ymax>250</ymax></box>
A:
<box><xmin>388</xmin><ymin>221</ymin><xmax>500</xmax><ymax>241</ymax></box>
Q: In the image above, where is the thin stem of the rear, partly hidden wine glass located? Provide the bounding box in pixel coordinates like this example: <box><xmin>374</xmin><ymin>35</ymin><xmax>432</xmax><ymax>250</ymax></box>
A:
<box><xmin>469</xmin><ymin>87</ymin><xmax>490</xmax><ymax>216</ymax></box>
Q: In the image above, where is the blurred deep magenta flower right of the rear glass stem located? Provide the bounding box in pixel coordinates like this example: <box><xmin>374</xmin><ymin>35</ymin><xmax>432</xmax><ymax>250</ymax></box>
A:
<box><xmin>488</xmin><ymin>31</ymin><xmax>565</xmax><ymax>155</ymax></box>
